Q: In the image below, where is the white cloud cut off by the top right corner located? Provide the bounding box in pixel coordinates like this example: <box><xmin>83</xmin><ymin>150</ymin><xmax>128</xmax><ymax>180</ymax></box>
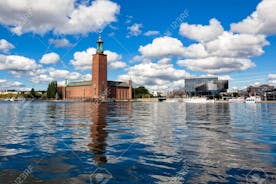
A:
<box><xmin>231</xmin><ymin>0</ymin><xmax>276</xmax><ymax>35</ymax></box>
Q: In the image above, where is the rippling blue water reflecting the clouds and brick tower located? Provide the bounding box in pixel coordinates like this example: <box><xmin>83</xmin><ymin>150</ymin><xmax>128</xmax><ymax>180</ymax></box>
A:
<box><xmin>0</xmin><ymin>102</ymin><xmax>276</xmax><ymax>184</ymax></box>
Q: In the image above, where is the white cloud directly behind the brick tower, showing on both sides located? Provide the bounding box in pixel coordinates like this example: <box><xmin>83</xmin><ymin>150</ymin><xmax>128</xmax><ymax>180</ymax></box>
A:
<box><xmin>70</xmin><ymin>48</ymin><xmax>127</xmax><ymax>70</ymax></box>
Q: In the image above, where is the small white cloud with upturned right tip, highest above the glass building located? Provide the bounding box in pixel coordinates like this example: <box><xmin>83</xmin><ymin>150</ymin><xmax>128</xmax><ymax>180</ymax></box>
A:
<box><xmin>179</xmin><ymin>18</ymin><xmax>224</xmax><ymax>42</ymax></box>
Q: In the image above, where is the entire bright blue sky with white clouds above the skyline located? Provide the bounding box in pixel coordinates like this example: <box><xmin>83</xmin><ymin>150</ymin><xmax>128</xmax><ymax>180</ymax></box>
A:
<box><xmin>0</xmin><ymin>0</ymin><xmax>276</xmax><ymax>91</ymax></box>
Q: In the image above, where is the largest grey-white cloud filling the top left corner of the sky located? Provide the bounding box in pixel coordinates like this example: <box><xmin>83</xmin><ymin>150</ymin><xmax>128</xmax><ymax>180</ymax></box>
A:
<box><xmin>0</xmin><ymin>0</ymin><xmax>120</xmax><ymax>35</ymax></box>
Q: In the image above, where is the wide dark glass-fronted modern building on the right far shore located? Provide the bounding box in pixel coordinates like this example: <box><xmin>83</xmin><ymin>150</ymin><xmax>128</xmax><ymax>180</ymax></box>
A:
<box><xmin>184</xmin><ymin>77</ymin><xmax>228</xmax><ymax>96</ymax></box>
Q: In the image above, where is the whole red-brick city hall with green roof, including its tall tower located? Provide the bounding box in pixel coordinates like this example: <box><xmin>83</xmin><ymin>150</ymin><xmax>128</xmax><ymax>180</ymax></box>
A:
<box><xmin>58</xmin><ymin>36</ymin><xmax>132</xmax><ymax>100</ymax></box>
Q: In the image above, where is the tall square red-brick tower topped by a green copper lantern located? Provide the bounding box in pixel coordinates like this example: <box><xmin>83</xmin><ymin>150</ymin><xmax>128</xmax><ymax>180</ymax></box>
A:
<box><xmin>92</xmin><ymin>35</ymin><xmax>108</xmax><ymax>98</ymax></box>
